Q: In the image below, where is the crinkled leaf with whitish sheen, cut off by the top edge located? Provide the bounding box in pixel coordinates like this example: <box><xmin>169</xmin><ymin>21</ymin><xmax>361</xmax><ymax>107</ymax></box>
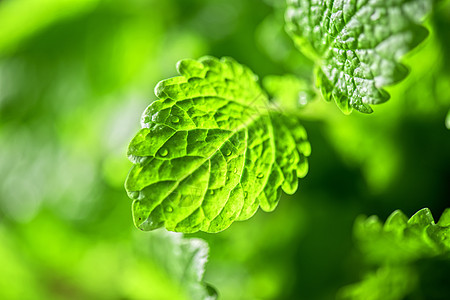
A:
<box><xmin>286</xmin><ymin>0</ymin><xmax>432</xmax><ymax>113</ymax></box>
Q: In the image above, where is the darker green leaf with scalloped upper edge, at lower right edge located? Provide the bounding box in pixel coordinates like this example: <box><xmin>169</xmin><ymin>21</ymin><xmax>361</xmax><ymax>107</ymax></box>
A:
<box><xmin>355</xmin><ymin>208</ymin><xmax>450</xmax><ymax>263</ymax></box>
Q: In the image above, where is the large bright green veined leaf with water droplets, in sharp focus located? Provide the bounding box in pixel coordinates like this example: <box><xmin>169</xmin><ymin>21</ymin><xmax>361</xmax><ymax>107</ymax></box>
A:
<box><xmin>125</xmin><ymin>57</ymin><xmax>311</xmax><ymax>232</ymax></box>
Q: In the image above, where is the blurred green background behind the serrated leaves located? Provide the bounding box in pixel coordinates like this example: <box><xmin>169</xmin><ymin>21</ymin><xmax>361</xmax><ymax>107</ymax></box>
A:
<box><xmin>0</xmin><ymin>0</ymin><xmax>450</xmax><ymax>300</ymax></box>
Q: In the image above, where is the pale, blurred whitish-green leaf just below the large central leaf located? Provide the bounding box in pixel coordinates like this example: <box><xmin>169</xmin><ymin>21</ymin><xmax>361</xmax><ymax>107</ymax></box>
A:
<box><xmin>141</xmin><ymin>230</ymin><xmax>217</xmax><ymax>300</ymax></box>
